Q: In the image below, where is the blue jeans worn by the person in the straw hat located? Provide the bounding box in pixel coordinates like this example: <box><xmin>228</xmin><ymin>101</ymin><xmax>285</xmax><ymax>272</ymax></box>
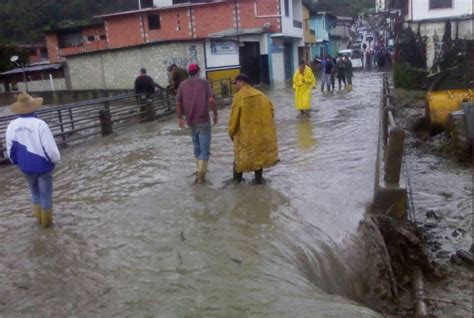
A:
<box><xmin>25</xmin><ymin>172</ymin><xmax>53</xmax><ymax>211</ymax></box>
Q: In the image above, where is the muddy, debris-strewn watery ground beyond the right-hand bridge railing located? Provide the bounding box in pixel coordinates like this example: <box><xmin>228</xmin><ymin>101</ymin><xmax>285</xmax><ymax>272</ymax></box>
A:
<box><xmin>394</xmin><ymin>90</ymin><xmax>474</xmax><ymax>317</ymax></box>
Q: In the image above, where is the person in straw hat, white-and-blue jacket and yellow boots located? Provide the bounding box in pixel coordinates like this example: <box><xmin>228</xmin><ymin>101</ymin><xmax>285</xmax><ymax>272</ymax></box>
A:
<box><xmin>6</xmin><ymin>92</ymin><xmax>61</xmax><ymax>228</ymax></box>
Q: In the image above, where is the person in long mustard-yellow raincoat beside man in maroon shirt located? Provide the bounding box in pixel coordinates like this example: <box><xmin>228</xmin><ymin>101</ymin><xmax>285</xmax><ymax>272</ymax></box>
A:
<box><xmin>228</xmin><ymin>74</ymin><xmax>279</xmax><ymax>184</ymax></box>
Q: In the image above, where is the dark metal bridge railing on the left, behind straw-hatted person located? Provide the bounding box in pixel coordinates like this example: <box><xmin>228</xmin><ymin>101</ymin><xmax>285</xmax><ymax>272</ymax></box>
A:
<box><xmin>0</xmin><ymin>79</ymin><xmax>232</xmax><ymax>163</ymax></box>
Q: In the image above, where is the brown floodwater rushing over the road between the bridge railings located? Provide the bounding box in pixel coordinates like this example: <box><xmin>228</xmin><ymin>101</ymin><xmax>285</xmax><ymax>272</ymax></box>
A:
<box><xmin>0</xmin><ymin>73</ymin><xmax>382</xmax><ymax>317</ymax></box>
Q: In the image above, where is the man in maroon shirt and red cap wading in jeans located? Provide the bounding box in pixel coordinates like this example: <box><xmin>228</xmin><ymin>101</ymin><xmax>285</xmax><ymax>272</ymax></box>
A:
<box><xmin>176</xmin><ymin>64</ymin><xmax>217</xmax><ymax>183</ymax></box>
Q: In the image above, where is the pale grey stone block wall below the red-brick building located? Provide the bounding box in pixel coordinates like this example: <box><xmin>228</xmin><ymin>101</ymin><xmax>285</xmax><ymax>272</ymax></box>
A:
<box><xmin>67</xmin><ymin>41</ymin><xmax>204</xmax><ymax>90</ymax></box>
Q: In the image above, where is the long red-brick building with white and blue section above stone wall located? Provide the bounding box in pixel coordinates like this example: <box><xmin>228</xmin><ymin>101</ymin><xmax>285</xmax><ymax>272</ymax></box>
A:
<box><xmin>47</xmin><ymin>0</ymin><xmax>304</xmax><ymax>88</ymax></box>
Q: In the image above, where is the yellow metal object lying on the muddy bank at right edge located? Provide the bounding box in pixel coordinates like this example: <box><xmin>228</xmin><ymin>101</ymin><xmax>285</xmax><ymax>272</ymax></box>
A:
<box><xmin>425</xmin><ymin>89</ymin><xmax>474</xmax><ymax>129</ymax></box>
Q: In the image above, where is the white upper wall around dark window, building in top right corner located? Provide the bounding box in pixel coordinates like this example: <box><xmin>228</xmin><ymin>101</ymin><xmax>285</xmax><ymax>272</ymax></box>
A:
<box><xmin>407</xmin><ymin>0</ymin><xmax>473</xmax><ymax>21</ymax></box>
